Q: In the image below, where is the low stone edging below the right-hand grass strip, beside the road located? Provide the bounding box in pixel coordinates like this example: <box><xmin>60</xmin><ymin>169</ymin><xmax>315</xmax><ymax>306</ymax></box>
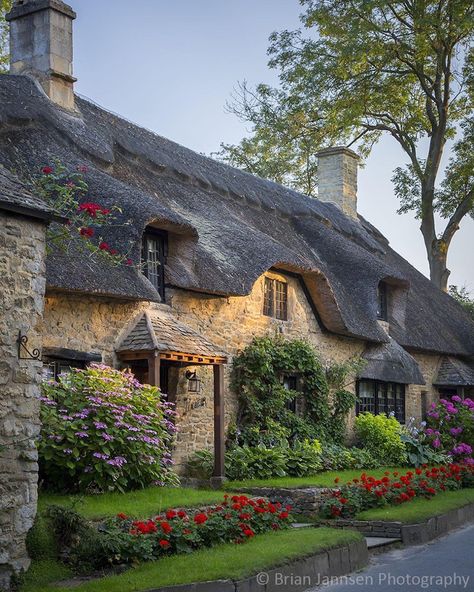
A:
<box><xmin>319</xmin><ymin>503</ymin><xmax>474</xmax><ymax>546</ymax></box>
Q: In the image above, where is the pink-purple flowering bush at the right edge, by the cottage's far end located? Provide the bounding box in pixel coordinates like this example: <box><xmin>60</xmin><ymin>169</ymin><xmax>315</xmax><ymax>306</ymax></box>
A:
<box><xmin>426</xmin><ymin>395</ymin><xmax>474</xmax><ymax>464</ymax></box>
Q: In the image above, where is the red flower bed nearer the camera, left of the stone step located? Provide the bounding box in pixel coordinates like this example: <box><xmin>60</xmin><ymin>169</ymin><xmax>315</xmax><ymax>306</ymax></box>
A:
<box><xmin>108</xmin><ymin>495</ymin><xmax>291</xmax><ymax>560</ymax></box>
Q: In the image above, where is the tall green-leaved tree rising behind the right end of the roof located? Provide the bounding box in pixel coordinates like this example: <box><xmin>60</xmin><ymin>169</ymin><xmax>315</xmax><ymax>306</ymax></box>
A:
<box><xmin>220</xmin><ymin>0</ymin><xmax>474</xmax><ymax>290</ymax></box>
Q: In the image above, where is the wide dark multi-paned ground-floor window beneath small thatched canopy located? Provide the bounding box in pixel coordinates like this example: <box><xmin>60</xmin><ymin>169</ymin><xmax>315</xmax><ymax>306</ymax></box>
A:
<box><xmin>356</xmin><ymin>378</ymin><xmax>406</xmax><ymax>424</ymax></box>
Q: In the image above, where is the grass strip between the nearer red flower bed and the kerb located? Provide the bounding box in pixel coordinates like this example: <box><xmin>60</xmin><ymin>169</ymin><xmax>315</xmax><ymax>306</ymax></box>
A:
<box><xmin>21</xmin><ymin>528</ymin><xmax>362</xmax><ymax>592</ymax></box>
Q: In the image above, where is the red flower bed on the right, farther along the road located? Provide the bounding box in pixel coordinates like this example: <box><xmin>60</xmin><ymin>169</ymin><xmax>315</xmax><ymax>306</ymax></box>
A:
<box><xmin>320</xmin><ymin>464</ymin><xmax>474</xmax><ymax>518</ymax></box>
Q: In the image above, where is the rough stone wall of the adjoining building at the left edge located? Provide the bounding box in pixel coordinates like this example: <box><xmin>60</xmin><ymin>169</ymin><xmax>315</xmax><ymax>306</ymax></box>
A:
<box><xmin>0</xmin><ymin>211</ymin><xmax>45</xmax><ymax>590</ymax></box>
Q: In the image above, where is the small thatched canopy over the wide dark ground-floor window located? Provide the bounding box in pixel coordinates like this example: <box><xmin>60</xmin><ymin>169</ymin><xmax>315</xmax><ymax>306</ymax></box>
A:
<box><xmin>359</xmin><ymin>338</ymin><xmax>425</xmax><ymax>384</ymax></box>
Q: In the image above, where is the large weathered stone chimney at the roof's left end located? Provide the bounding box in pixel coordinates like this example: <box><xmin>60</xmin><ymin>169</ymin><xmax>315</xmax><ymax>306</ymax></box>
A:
<box><xmin>6</xmin><ymin>0</ymin><xmax>76</xmax><ymax>111</ymax></box>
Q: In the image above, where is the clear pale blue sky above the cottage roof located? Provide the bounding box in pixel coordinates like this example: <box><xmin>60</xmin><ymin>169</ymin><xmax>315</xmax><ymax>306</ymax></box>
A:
<box><xmin>69</xmin><ymin>0</ymin><xmax>474</xmax><ymax>292</ymax></box>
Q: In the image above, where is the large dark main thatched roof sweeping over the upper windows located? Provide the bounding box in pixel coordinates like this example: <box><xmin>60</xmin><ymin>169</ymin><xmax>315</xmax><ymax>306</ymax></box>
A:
<box><xmin>0</xmin><ymin>76</ymin><xmax>474</xmax><ymax>354</ymax></box>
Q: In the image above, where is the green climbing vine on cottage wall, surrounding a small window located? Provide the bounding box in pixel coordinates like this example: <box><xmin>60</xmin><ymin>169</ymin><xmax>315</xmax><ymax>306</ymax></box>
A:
<box><xmin>229</xmin><ymin>336</ymin><xmax>360</xmax><ymax>446</ymax></box>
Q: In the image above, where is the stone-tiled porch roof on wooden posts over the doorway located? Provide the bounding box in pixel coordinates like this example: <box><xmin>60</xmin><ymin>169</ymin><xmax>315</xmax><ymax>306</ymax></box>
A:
<box><xmin>117</xmin><ymin>310</ymin><xmax>228</xmax><ymax>358</ymax></box>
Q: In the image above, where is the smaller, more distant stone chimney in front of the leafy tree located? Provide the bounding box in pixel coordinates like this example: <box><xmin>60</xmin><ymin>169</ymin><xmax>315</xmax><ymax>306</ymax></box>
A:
<box><xmin>317</xmin><ymin>146</ymin><xmax>359</xmax><ymax>219</ymax></box>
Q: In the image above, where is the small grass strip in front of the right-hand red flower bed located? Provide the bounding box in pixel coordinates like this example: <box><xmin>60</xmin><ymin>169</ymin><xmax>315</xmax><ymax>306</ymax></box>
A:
<box><xmin>356</xmin><ymin>489</ymin><xmax>474</xmax><ymax>524</ymax></box>
